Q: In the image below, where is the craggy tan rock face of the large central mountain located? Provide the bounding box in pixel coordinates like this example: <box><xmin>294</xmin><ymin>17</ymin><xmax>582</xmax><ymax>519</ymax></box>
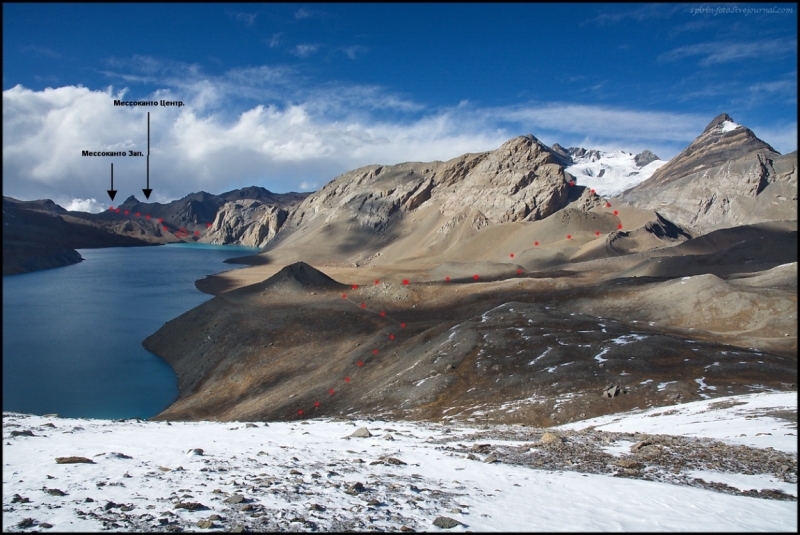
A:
<box><xmin>268</xmin><ymin>135</ymin><xmax>569</xmax><ymax>255</ymax></box>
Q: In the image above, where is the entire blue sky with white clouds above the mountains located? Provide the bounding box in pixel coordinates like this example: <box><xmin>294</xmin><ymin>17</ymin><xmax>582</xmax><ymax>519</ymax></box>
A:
<box><xmin>3</xmin><ymin>4</ymin><xmax>797</xmax><ymax>210</ymax></box>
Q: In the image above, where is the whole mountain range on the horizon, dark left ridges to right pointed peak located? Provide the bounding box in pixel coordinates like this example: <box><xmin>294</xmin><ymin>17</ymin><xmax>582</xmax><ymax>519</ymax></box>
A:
<box><xmin>3</xmin><ymin>114</ymin><xmax>797</xmax><ymax>274</ymax></box>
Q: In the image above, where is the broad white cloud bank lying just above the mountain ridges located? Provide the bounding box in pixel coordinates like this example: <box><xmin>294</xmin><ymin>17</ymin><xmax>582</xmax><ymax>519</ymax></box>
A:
<box><xmin>3</xmin><ymin>70</ymin><xmax>797</xmax><ymax>206</ymax></box>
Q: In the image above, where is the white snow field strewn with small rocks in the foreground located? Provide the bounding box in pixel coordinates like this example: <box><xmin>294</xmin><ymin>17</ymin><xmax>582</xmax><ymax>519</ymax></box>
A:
<box><xmin>3</xmin><ymin>392</ymin><xmax>797</xmax><ymax>532</ymax></box>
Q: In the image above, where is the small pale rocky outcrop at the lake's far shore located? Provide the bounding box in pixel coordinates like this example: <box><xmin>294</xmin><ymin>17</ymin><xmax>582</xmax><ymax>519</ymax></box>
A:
<box><xmin>200</xmin><ymin>199</ymin><xmax>289</xmax><ymax>247</ymax></box>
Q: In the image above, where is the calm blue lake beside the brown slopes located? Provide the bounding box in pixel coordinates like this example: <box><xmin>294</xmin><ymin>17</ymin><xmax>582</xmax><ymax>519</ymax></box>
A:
<box><xmin>3</xmin><ymin>244</ymin><xmax>257</xmax><ymax>418</ymax></box>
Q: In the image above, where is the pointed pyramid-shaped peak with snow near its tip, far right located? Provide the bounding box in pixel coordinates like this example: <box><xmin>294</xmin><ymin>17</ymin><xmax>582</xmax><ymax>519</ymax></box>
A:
<box><xmin>619</xmin><ymin>114</ymin><xmax>797</xmax><ymax>231</ymax></box>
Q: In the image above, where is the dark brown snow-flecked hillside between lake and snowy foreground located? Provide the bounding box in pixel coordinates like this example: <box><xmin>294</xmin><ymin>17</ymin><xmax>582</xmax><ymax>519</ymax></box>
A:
<box><xmin>144</xmin><ymin>258</ymin><xmax>797</xmax><ymax>425</ymax></box>
